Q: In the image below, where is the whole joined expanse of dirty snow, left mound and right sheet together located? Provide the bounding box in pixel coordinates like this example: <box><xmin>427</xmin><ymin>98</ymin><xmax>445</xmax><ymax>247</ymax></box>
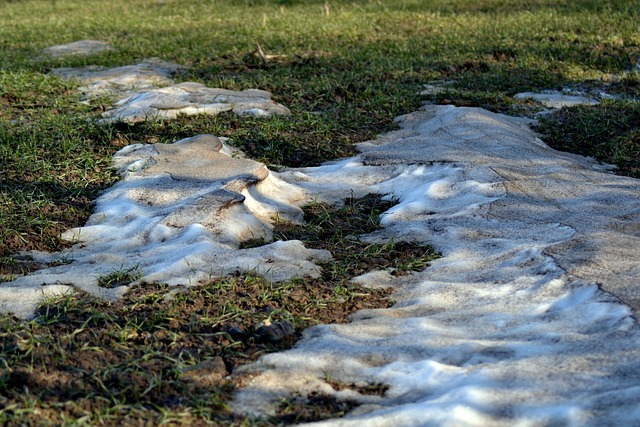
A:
<box><xmin>0</xmin><ymin>106</ymin><xmax>640</xmax><ymax>426</ymax></box>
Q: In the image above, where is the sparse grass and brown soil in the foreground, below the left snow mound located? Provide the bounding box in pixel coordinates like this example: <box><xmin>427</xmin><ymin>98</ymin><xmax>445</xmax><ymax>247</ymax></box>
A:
<box><xmin>0</xmin><ymin>276</ymin><xmax>389</xmax><ymax>426</ymax></box>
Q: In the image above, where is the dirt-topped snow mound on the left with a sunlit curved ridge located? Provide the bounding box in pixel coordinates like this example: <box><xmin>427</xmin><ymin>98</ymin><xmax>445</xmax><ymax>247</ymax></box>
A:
<box><xmin>0</xmin><ymin>135</ymin><xmax>331</xmax><ymax>317</ymax></box>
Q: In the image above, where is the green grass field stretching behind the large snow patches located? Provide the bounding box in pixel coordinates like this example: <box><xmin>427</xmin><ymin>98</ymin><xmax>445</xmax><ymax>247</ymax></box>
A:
<box><xmin>0</xmin><ymin>0</ymin><xmax>640</xmax><ymax>258</ymax></box>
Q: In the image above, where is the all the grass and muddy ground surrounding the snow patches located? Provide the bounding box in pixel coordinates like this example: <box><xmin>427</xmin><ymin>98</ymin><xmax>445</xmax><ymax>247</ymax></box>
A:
<box><xmin>0</xmin><ymin>0</ymin><xmax>640</xmax><ymax>425</ymax></box>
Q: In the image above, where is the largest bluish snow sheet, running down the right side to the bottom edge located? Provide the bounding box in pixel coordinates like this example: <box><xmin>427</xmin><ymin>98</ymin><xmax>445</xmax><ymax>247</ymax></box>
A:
<box><xmin>234</xmin><ymin>106</ymin><xmax>640</xmax><ymax>426</ymax></box>
